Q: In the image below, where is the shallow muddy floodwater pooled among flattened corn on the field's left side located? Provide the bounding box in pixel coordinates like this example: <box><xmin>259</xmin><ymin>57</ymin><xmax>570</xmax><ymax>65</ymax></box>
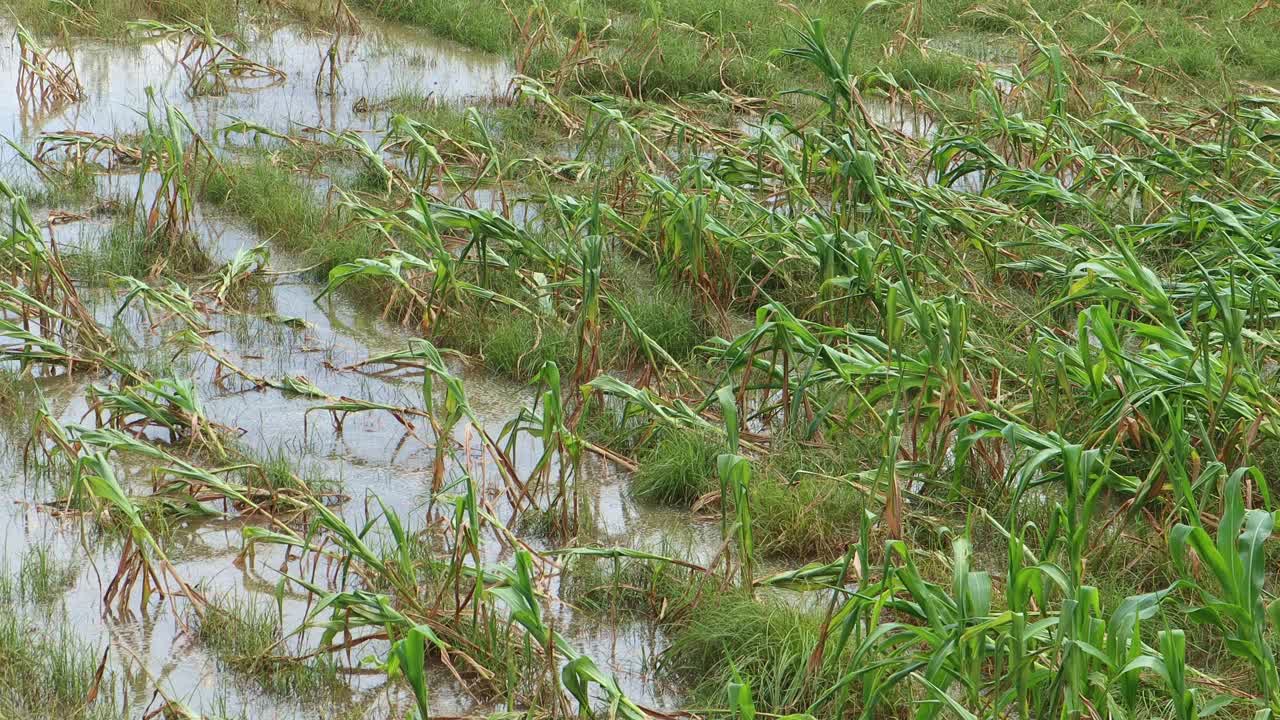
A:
<box><xmin>0</xmin><ymin>11</ymin><xmax>718</xmax><ymax>719</ymax></box>
